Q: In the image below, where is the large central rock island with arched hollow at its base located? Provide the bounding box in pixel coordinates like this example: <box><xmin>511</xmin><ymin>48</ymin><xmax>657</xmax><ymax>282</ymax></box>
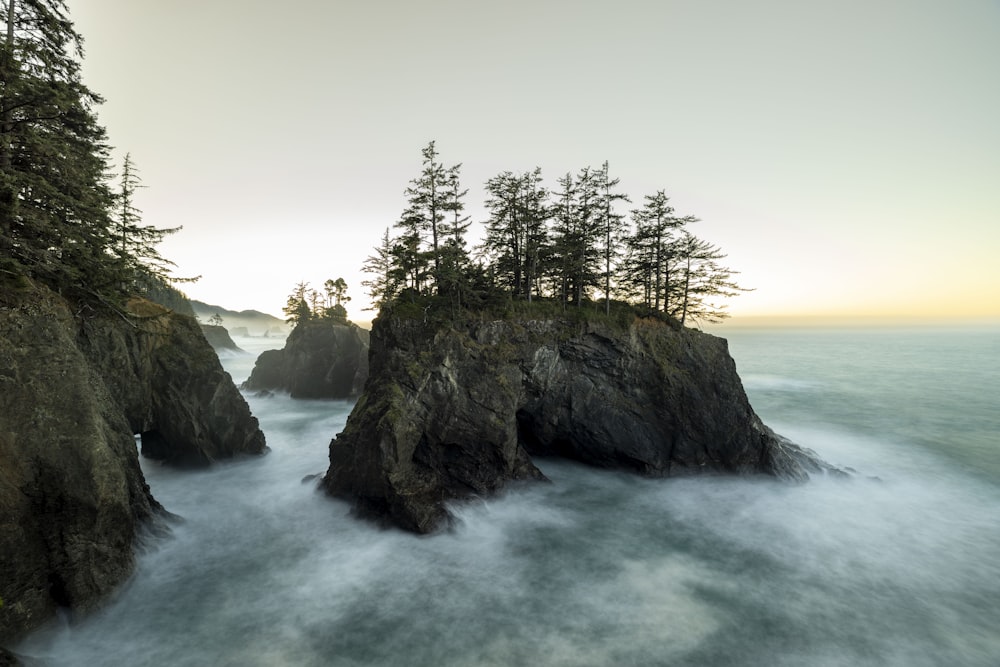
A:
<box><xmin>323</xmin><ymin>317</ymin><xmax>823</xmax><ymax>533</ymax></box>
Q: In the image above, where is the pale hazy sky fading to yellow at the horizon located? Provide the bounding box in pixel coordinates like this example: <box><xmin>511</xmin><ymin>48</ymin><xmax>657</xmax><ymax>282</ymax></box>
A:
<box><xmin>68</xmin><ymin>0</ymin><xmax>1000</xmax><ymax>322</ymax></box>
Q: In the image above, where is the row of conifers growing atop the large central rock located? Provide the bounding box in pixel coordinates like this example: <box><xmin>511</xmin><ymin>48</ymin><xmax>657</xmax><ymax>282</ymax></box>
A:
<box><xmin>363</xmin><ymin>142</ymin><xmax>745</xmax><ymax>324</ymax></box>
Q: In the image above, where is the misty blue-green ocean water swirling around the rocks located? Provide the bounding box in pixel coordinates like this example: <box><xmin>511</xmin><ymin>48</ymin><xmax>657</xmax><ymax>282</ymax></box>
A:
<box><xmin>16</xmin><ymin>328</ymin><xmax>1000</xmax><ymax>667</ymax></box>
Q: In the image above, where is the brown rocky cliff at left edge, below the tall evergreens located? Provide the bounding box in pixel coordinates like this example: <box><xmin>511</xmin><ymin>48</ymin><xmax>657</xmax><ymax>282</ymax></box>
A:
<box><xmin>0</xmin><ymin>284</ymin><xmax>266</xmax><ymax>642</ymax></box>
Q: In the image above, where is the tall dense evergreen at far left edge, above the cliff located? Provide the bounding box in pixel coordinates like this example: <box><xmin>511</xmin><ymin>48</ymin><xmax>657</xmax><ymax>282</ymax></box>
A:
<box><xmin>0</xmin><ymin>0</ymin><xmax>121</xmax><ymax>294</ymax></box>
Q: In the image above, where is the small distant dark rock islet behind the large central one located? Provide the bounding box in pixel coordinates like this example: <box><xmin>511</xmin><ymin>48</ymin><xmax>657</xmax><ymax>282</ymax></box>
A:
<box><xmin>243</xmin><ymin>321</ymin><xmax>369</xmax><ymax>398</ymax></box>
